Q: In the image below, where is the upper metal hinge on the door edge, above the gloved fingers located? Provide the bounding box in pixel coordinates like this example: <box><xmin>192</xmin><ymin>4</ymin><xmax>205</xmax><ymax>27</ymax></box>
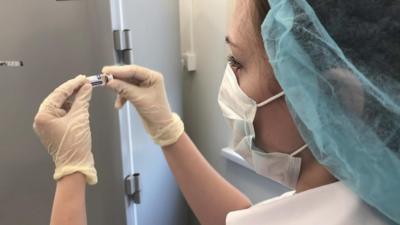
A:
<box><xmin>114</xmin><ymin>29</ymin><xmax>133</xmax><ymax>65</ymax></box>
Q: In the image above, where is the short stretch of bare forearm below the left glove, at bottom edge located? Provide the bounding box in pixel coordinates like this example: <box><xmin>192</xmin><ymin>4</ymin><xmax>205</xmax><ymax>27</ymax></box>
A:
<box><xmin>50</xmin><ymin>173</ymin><xmax>87</xmax><ymax>225</ymax></box>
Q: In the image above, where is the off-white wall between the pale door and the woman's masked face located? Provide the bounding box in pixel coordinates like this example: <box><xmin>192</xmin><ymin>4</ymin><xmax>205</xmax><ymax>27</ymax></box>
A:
<box><xmin>183</xmin><ymin>0</ymin><xmax>285</xmax><ymax>223</ymax></box>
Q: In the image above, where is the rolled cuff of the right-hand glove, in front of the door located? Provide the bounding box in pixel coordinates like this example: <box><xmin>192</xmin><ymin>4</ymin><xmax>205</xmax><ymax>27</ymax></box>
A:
<box><xmin>153</xmin><ymin>113</ymin><xmax>185</xmax><ymax>147</ymax></box>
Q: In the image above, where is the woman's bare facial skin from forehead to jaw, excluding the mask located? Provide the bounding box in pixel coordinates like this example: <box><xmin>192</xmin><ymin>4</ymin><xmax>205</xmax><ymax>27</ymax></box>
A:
<box><xmin>226</xmin><ymin>0</ymin><xmax>304</xmax><ymax>154</ymax></box>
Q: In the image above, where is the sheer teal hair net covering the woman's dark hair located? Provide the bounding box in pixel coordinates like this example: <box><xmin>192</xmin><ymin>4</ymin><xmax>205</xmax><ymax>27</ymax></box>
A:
<box><xmin>262</xmin><ymin>0</ymin><xmax>400</xmax><ymax>223</ymax></box>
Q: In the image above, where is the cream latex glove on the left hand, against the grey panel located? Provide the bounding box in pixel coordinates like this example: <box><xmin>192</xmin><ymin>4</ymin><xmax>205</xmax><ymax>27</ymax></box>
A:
<box><xmin>33</xmin><ymin>75</ymin><xmax>97</xmax><ymax>185</ymax></box>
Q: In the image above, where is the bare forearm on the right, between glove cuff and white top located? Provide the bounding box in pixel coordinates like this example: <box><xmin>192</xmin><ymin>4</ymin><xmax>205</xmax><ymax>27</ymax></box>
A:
<box><xmin>163</xmin><ymin>134</ymin><xmax>251</xmax><ymax>225</ymax></box>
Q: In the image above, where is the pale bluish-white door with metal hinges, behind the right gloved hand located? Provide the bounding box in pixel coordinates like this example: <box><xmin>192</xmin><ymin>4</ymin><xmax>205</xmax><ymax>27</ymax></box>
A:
<box><xmin>113</xmin><ymin>0</ymin><xmax>188</xmax><ymax>225</ymax></box>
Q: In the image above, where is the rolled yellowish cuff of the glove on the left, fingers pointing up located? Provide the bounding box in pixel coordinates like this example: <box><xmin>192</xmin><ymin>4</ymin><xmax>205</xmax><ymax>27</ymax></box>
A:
<box><xmin>53</xmin><ymin>166</ymin><xmax>97</xmax><ymax>185</ymax></box>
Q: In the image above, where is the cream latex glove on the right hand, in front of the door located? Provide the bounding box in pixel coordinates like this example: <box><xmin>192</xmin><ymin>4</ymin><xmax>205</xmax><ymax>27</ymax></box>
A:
<box><xmin>102</xmin><ymin>65</ymin><xmax>184</xmax><ymax>146</ymax></box>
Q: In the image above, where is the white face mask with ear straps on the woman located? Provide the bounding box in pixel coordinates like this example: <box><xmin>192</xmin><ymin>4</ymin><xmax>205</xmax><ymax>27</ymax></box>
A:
<box><xmin>218</xmin><ymin>65</ymin><xmax>307</xmax><ymax>189</ymax></box>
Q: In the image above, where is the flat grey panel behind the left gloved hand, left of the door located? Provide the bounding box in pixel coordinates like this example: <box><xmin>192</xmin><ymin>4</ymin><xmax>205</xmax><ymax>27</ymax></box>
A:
<box><xmin>0</xmin><ymin>0</ymin><xmax>125</xmax><ymax>225</ymax></box>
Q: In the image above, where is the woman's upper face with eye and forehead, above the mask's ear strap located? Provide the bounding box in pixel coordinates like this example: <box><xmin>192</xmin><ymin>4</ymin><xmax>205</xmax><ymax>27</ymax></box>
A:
<box><xmin>227</xmin><ymin>0</ymin><xmax>280</xmax><ymax>102</ymax></box>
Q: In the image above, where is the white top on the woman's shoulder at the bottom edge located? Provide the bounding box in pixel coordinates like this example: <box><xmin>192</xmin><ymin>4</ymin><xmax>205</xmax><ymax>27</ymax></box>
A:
<box><xmin>226</xmin><ymin>182</ymin><xmax>391</xmax><ymax>225</ymax></box>
